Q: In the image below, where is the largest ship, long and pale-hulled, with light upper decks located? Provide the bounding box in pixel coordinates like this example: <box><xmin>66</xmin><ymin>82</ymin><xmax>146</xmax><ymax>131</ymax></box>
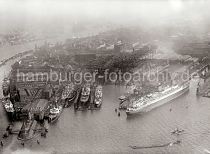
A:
<box><xmin>126</xmin><ymin>82</ymin><xmax>189</xmax><ymax>115</ymax></box>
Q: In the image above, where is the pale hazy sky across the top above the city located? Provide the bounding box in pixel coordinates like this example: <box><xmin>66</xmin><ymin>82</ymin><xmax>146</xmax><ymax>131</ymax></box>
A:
<box><xmin>0</xmin><ymin>0</ymin><xmax>210</xmax><ymax>34</ymax></box>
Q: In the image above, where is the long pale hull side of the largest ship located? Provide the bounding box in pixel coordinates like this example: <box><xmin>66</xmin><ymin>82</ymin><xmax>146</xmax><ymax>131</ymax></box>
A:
<box><xmin>126</xmin><ymin>86</ymin><xmax>189</xmax><ymax>115</ymax></box>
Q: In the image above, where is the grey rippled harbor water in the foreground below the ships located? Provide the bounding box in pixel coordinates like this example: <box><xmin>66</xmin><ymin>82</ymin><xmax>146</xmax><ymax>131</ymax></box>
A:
<box><xmin>0</xmin><ymin>81</ymin><xmax>210</xmax><ymax>154</ymax></box>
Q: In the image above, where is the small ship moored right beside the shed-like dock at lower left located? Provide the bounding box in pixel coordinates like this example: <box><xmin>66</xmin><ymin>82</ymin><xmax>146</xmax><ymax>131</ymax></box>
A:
<box><xmin>49</xmin><ymin>105</ymin><xmax>63</xmax><ymax>123</ymax></box>
